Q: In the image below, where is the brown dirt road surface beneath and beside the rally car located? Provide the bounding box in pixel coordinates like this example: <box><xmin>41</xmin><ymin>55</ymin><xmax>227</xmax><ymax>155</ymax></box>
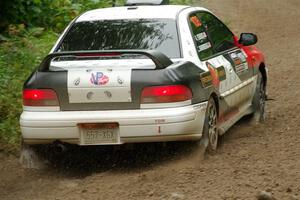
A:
<box><xmin>0</xmin><ymin>0</ymin><xmax>300</xmax><ymax>200</ymax></box>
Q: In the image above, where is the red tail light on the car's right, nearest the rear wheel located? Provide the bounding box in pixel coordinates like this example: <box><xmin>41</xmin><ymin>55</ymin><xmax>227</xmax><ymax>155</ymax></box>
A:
<box><xmin>141</xmin><ymin>85</ymin><xmax>193</xmax><ymax>103</ymax></box>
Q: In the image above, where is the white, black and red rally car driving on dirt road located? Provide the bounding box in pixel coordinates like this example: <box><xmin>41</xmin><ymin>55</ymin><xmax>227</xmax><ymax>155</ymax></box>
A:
<box><xmin>20</xmin><ymin>1</ymin><xmax>267</xmax><ymax>157</ymax></box>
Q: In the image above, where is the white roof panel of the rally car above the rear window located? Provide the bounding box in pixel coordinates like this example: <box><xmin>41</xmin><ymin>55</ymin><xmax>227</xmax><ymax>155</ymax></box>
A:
<box><xmin>76</xmin><ymin>5</ymin><xmax>205</xmax><ymax>22</ymax></box>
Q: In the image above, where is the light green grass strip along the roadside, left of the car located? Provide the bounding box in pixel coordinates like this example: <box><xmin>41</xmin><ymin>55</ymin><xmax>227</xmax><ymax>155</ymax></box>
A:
<box><xmin>0</xmin><ymin>31</ymin><xmax>58</xmax><ymax>147</ymax></box>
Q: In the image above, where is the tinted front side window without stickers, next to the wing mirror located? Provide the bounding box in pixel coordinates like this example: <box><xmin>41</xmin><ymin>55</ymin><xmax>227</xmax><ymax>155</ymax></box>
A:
<box><xmin>197</xmin><ymin>12</ymin><xmax>234</xmax><ymax>53</ymax></box>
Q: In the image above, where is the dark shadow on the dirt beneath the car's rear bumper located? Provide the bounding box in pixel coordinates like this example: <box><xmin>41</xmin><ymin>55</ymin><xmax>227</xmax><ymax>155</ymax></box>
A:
<box><xmin>42</xmin><ymin>142</ymin><xmax>198</xmax><ymax>176</ymax></box>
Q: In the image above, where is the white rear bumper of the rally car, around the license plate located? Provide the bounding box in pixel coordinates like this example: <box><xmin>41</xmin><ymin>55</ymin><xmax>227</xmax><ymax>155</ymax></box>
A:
<box><xmin>20</xmin><ymin>102</ymin><xmax>207</xmax><ymax>145</ymax></box>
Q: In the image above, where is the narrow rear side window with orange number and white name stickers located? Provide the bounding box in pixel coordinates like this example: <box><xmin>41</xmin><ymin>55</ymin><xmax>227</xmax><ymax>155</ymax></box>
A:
<box><xmin>189</xmin><ymin>15</ymin><xmax>213</xmax><ymax>60</ymax></box>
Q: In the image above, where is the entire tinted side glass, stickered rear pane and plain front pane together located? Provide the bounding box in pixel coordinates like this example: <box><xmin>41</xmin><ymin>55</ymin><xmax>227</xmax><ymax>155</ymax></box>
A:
<box><xmin>189</xmin><ymin>12</ymin><xmax>234</xmax><ymax>60</ymax></box>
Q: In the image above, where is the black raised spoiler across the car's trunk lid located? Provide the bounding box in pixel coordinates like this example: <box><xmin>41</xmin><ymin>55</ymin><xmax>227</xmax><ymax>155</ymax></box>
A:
<box><xmin>38</xmin><ymin>50</ymin><xmax>173</xmax><ymax>71</ymax></box>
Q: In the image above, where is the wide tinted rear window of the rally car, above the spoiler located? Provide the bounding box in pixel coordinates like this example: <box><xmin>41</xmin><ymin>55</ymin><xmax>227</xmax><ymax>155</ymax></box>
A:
<box><xmin>58</xmin><ymin>19</ymin><xmax>180</xmax><ymax>58</ymax></box>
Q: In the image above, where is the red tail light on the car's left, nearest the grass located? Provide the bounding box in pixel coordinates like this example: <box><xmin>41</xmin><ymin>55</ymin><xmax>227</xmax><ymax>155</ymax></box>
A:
<box><xmin>23</xmin><ymin>89</ymin><xmax>59</xmax><ymax>106</ymax></box>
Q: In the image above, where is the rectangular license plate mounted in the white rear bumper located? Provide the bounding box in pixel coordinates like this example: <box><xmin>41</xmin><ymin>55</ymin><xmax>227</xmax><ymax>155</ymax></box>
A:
<box><xmin>78</xmin><ymin>123</ymin><xmax>120</xmax><ymax>145</ymax></box>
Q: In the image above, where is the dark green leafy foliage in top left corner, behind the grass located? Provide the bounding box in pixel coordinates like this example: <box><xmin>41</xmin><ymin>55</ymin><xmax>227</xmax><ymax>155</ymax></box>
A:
<box><xmin>0</xmin><ymin>0</ymin><xmax>119</xmax><ymax>32</ymax></box>
